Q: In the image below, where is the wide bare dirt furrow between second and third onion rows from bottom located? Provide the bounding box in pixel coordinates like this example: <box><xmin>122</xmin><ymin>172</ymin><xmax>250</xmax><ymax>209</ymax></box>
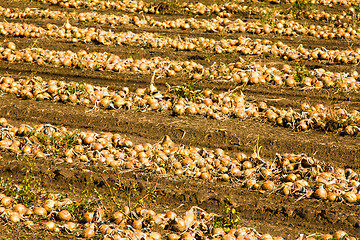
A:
<box><xmin>0</xmin><ymin>96</ymin><xmax>360</xmax><ymax>169</ymax></box>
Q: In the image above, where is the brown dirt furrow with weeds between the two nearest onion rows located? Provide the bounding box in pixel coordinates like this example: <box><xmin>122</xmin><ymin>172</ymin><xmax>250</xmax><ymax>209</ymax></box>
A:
<box><xmin>0</xmin><ymin>150</ymin><xmax>360</xmax><ymax>239</ymax></box>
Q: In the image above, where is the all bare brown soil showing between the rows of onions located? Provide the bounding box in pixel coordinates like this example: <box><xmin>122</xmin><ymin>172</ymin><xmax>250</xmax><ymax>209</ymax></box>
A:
<box><xmin>0</xmin><ymin>0</ymin><xmax>360</xmax><ymax>239</ymax></box>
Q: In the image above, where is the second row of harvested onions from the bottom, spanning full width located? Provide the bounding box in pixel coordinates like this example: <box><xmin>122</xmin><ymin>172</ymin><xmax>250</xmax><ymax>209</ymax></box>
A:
<box><xmin>0</xmin><ymin>115</ymin><xmax>360</xmax><ymax>204</ymax></box>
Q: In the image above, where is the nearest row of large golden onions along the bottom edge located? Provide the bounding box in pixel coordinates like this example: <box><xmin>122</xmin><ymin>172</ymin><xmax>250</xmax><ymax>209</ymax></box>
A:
<box><xmin>0</xmin><ymin>186</ymin><xmax>356</xmax><ymax>240</ymax></box>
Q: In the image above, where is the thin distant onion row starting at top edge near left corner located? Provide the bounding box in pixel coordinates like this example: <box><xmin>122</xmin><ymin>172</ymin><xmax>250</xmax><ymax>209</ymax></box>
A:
<box><xmin>32</xmin><ymin>0</ymin><xmax>360</xmax><ymax>22</ymax></box>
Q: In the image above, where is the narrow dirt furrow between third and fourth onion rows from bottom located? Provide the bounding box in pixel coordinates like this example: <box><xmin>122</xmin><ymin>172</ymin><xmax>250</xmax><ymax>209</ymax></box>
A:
<box><xmin>0</xmin><ymin>54</ymin><xmax>360</xmax><ymax>110</ymax></box>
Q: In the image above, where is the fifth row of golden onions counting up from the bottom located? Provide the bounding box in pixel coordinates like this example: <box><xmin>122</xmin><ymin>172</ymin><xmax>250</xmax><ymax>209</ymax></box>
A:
<box><xmin>0</xmin><ymin>22</ymin><xmax>360</xmax><ymax>64</ymax></box>
